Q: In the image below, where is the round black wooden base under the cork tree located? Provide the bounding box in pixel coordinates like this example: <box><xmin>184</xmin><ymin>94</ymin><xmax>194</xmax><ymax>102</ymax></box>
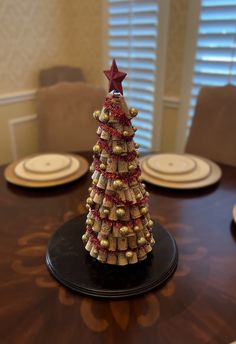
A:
<box><xmin>46</xmin><ymin>215</ymin><xmax>178</xmax><ymax>299</ymax></box>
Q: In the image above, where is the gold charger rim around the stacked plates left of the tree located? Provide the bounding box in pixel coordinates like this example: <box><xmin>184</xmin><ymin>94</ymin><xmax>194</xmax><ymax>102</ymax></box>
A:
<box><xmin>4</xmin><ymin>154</ymin><xmax>89</xmax><ymax>188</ymax></box>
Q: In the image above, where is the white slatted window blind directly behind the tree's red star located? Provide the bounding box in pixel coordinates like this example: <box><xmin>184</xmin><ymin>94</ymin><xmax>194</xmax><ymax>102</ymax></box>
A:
<box><xmin>108</xmin><ymin>0</ymin><xmax>159</xmax><ymax>150</ymax></box>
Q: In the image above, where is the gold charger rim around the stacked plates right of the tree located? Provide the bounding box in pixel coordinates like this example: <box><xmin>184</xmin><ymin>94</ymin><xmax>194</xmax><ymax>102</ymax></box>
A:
<box><xmin>140</xmin><ymin>155</ymin><xmax>222</xmax><ymax>189</ymax></box>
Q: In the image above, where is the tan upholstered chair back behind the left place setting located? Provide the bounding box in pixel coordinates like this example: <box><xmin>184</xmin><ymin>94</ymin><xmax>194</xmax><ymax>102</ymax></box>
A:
<box><xmin>36</xmin><ymin>82</ymin><xmax>105</xmax><ymax>152</ymax></box>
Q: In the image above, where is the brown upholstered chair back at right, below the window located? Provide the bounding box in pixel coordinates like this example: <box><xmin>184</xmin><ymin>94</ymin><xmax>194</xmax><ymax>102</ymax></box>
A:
<box><xmin>185</xmin><ymin>85</ymin><xmax>236</xmax><ymax>166</ymax></box>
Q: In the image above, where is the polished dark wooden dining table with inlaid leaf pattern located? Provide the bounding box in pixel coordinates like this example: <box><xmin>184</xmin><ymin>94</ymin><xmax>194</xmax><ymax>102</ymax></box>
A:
<box><xmin>0</xmin><ymin>153</ymin><xmax>236</xmax><ymax>344</ymax></box>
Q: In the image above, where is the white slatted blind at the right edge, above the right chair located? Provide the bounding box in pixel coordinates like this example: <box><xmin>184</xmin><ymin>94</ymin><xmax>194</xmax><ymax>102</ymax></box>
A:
<box><xmin>187</xmin><ymin>0</ymin><xmax>236</xmax><ymax>129</ymax></box>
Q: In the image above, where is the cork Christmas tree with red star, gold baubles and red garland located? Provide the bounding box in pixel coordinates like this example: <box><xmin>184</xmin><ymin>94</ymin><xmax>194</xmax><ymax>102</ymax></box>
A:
<box><xmin>82</xmin><ymin>60</ymin><xmax>155</xmax><ymax>265</ymax></box>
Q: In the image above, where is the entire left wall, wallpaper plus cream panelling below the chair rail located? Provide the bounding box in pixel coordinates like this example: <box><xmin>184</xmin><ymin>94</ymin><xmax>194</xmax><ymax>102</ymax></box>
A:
<box><xmin>0</xmin><ymin>0</ymin><xmax>103</xmax><ymax>164</ymax></box>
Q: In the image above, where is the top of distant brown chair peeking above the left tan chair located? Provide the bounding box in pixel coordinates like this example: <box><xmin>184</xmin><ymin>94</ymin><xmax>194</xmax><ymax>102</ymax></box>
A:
<box><xmin>39</xmin><ymin>66</ymin><xmax>84</xmax><ymax>87</ymax></box>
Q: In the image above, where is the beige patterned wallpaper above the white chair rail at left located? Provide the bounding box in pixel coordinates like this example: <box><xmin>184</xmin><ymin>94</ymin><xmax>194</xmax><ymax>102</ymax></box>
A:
<box><xmin>0</xmin><ymin>0</ymin><xmax>103</xmax><ymax>94</ymax></box>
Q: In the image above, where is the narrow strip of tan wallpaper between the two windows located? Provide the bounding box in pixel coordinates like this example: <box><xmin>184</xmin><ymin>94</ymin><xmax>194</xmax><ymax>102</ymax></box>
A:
<box><xmin>165</xmin><ymin>0</ymin><xmax>188</xmax><ymax>97</ymax></box>
